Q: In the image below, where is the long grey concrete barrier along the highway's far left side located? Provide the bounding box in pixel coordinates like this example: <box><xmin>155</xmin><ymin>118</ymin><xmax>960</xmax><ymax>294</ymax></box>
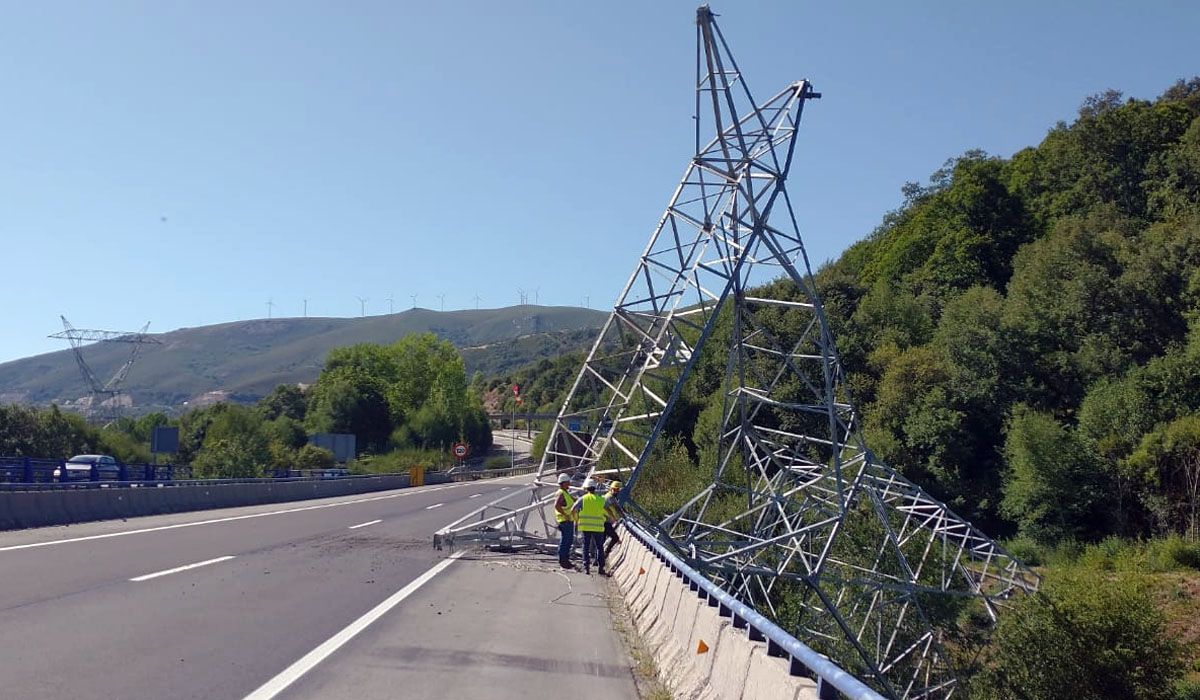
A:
<box><xmin>0</xmin><ymin>473</ymin><xmax>450</xmax><ymax>530</ymax></box>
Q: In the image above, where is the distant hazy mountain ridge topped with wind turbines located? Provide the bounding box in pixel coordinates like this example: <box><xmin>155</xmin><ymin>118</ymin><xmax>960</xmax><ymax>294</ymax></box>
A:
<box><xmin>0</xmin><ymin>305</ymin><xmax>607</xmax><ymax>407</ymax></box>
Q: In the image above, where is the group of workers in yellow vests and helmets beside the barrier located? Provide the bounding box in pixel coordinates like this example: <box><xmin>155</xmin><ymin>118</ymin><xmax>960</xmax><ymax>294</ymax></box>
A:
<box><xmin>554</xmin><ymin>472</ymin><xmax>622</xmax><ymax>576</ymax></box>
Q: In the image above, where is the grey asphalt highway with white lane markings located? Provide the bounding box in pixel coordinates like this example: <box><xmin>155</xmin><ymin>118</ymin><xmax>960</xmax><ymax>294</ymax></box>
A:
<box><xmin>0</xmin><ymin>475</ymin><xmax>636</xmax><ymax>700</ymax></box>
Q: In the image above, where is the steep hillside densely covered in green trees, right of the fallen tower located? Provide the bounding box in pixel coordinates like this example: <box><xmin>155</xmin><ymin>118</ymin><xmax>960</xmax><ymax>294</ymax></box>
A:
<box><xmin>817</xmin><ymin>80</ymin><xmax>1200</xmax><ymax>542</ymax></box>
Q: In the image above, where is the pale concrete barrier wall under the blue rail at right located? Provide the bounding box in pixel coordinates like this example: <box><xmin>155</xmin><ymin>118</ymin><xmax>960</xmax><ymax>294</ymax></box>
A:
<box><xmin>612</xmin><ymin>536</ymin><xmax>817</xmax><ymax>700</ymax></box>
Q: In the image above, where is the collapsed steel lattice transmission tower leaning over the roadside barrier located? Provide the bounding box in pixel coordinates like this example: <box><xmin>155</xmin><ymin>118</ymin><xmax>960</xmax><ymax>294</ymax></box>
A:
<box><xmin>434</xmin><ymin>6</ymin><xmax>1038</xmax><ymax>698</ymax></box>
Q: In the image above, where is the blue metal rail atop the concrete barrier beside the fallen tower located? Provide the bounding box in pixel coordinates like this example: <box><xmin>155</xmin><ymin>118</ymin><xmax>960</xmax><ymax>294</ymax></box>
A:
<box><xmin>625</xmin><ymin>520</ymin><xmax>886</xmax><ymax>700</ymax></box>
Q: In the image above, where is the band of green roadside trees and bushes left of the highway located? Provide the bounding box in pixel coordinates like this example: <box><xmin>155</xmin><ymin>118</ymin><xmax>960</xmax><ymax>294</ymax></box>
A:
<box><xmin>0</xmin><ymin>334</ymin><xmax>491</xmax><ymax>478</ymax></box>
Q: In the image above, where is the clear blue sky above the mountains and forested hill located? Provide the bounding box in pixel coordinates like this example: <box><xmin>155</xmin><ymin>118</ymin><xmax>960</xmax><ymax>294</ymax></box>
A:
<box><xmin>0</xmin><ymin>0</ymin><xmax>1200</xmax><ymax>361</ymax></box>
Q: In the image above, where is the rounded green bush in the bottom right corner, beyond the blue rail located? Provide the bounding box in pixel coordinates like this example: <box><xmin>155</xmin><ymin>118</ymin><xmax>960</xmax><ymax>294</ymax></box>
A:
<box><xmin>971</xmin><ymin>572</ymin><xmax>1183</xmax><ymax>700</ymax></box>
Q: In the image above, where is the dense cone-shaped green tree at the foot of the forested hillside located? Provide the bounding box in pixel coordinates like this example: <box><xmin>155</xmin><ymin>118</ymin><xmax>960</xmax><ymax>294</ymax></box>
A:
<box><xmin>1001</xmin><ymin>406</ymin><xmax>1114</xmax><ymax>544</ymax></box>
